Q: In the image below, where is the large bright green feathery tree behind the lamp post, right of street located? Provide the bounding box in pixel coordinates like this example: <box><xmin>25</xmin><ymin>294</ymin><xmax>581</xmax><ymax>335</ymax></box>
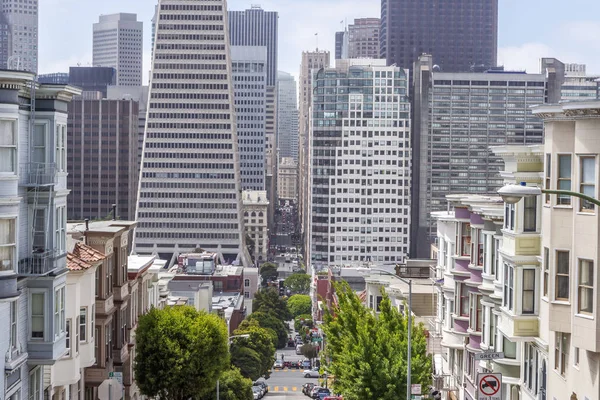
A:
<box><xmin>323</xmin><ymin>283</ymin><xmax>431</xmax><ymax>400</ymax></box>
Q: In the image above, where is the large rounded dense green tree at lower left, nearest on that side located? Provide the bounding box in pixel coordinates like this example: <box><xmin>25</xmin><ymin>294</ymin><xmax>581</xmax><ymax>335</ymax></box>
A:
<box><xmin>134</xmin><ymin>306</ymin><xmax>229</xmax><ymax>400</ymax></box>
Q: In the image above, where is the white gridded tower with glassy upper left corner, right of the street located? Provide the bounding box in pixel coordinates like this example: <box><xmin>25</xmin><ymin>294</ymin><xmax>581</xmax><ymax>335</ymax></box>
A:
<box><xmin>306</xmin><ymin>59</ymin><xmax>411</xmax><ymax>267</ymax></box>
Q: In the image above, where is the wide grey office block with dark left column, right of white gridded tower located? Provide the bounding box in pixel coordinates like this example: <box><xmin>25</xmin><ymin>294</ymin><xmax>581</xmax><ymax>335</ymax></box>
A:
<box><xmin>411</xmin><ymin>55</ymin><xmax>546</xmax><ymax>258</ymax></box>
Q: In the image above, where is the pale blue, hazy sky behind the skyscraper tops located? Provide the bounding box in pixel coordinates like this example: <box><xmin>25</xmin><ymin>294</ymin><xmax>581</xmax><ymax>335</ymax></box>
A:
<box><xmin>39</xmin><ymin>0</ymin><xmax>600</xmax><ymax>82</ymax></box>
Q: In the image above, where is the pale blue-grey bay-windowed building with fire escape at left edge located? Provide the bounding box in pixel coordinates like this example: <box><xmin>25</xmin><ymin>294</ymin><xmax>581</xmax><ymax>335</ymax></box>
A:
<box><xmin>0</xmin><ymin>72</ymin><xmax>81</xmax><ymax>400</ymax></box>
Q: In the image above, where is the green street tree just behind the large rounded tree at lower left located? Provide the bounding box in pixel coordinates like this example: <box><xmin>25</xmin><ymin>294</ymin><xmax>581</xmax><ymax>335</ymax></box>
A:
<box><xmin>231</xmin><ymin>320</ymin><xmax>278</xmax><ymax>380</ymax></box>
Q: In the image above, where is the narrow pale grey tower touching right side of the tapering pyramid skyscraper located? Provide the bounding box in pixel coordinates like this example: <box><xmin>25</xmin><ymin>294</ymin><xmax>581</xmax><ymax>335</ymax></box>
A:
<box><xmin>230</xmin><ymin>46</ymin><xmax>267</xmax><ymax>190</ymax></box>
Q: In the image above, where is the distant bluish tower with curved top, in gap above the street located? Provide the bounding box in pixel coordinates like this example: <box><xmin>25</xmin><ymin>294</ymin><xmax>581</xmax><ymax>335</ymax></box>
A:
<box><xmin>276</xmin><ymin>71</ymin><xmax>298</xmax><ymax>162</ymax></box>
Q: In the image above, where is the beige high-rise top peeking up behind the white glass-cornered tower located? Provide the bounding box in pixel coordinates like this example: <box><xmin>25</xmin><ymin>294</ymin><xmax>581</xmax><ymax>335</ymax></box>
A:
<box><xmin>346</xmin><ymin>18</ymin><xmax>381</xmax><ymax>59</ymax></box>
